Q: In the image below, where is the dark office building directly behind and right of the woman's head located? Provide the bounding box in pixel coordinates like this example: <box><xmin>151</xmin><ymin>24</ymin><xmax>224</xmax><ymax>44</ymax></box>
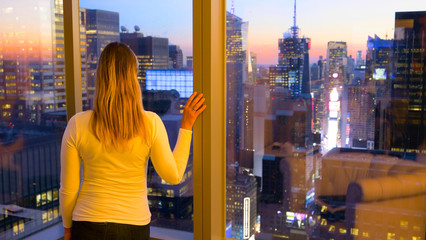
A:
<box><xmin>120</xmin><ymin>32</ymin><xmax>169</xmax><ymax>90</ymax></box>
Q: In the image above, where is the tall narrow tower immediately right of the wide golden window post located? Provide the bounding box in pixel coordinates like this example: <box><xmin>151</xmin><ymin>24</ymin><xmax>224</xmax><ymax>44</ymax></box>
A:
<box><xmin>226</xmin><ymin>12</ymin><xmax>248</xmax><ymax>174</ymax></box>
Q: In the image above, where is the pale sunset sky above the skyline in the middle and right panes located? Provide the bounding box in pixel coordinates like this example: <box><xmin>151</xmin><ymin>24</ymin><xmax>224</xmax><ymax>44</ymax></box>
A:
<box><xmin>80</xmin><ymin>0</ymin><xmax>426</xmax><ymax>65</ymax></box>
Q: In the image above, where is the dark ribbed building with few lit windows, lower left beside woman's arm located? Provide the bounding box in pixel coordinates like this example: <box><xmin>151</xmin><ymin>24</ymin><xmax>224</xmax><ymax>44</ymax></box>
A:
<box><xmin>0</xmin><ymin>132</ymin><xmax>62</xmax><ymax>239</ymax></box>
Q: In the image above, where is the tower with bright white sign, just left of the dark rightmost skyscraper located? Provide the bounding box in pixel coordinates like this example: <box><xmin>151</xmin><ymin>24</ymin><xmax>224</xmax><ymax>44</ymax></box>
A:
<box><xmin>358</xmin><ymin>35</ymin><xmax>393</xmax><ymax>149</ymax></box>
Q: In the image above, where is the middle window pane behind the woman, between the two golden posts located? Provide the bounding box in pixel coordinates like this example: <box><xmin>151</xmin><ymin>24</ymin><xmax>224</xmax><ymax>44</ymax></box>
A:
<box><xmin>80</xmin><ymin>0</ymin><xmax>193</xmax><ymax>234</ymax></box>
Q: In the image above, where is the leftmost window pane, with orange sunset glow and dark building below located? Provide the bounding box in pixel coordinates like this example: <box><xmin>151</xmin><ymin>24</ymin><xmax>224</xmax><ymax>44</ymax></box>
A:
<box><xmin>0</xmin><ymin>0</ymin><xmax>66</xmax><ymax>239</ymax></box>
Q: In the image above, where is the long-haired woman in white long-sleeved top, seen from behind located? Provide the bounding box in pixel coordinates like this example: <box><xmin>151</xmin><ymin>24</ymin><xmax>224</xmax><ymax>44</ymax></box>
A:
<box><xmin>60</xmin><ymin>43</ymin><xmax>206</xmax><ymax>240</ymax></box>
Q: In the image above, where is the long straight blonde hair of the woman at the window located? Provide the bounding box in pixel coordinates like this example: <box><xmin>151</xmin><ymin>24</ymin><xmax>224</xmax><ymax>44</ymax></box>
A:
<box><xmin>91</xmin><ymin>42</ymin><xmax>147</xmax><ymax>151</ymax></box>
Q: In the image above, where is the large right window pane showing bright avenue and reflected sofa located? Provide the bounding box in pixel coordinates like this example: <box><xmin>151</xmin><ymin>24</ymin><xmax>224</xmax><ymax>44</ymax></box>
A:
<box><xmin>226</xmin><ymin>0</ymin><xmax>426</xmax><ymax>240</ymax></box>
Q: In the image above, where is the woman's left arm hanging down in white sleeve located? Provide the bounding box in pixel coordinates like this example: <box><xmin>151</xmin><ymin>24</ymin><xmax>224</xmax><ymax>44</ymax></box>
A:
<box><xmin>59</xmin><ymin>116</ymin><xmax>80</xmax><ymax>229</ymax></box>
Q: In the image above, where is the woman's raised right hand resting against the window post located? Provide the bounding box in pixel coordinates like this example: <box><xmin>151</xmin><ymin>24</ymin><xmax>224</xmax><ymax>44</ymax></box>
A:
<box><xmin>181</xmin><ymin>92</ymin><xmax>207</xmax><ymax>130</ymax></box>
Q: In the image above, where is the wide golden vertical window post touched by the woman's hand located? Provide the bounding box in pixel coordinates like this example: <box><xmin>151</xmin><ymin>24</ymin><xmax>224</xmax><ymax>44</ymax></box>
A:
<box><xmin>193</xmin><ymin>0</ymin><xmax>226</xmax><ymax>239</ymax></box>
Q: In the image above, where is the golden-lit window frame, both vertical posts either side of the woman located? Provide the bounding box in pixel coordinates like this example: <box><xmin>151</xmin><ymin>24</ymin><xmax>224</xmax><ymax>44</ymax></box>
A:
<box><xmin>64</xmin><ymin>0</ymin><xmax>226</xmax><ymax>240</ymax></box>
